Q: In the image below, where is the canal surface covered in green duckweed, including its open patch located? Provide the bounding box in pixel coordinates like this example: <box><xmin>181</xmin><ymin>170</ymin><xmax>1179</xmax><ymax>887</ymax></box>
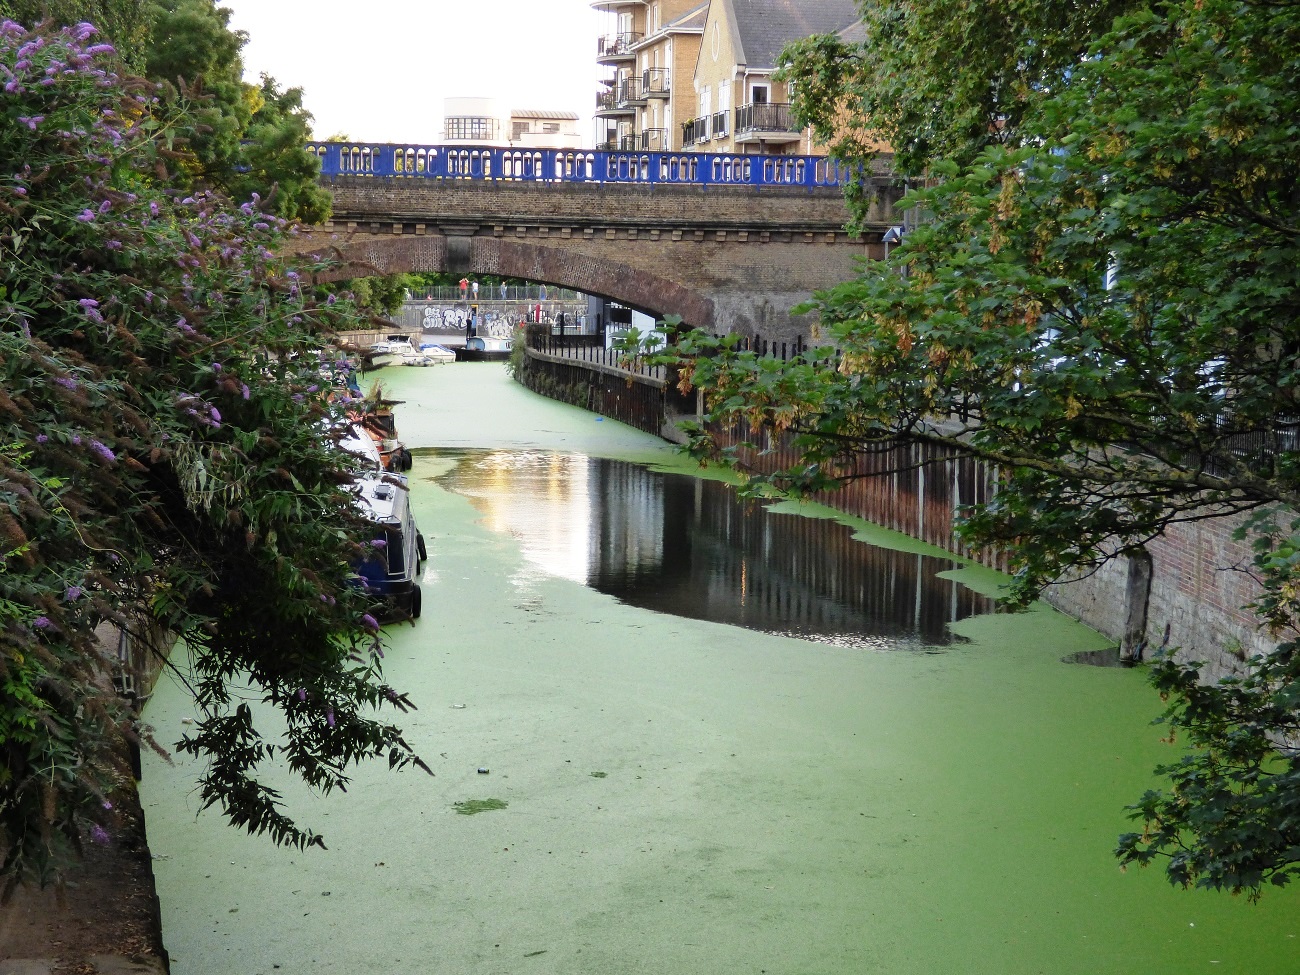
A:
<box><xmin>142</xmin><ymin>364</ymin><xmax>1300</xmax><ymax>975</ymax></box>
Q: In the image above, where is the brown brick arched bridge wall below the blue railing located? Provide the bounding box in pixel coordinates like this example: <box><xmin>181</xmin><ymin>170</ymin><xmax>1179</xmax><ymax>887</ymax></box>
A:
<box><xmin>295</xmin><ymin>147</ymin><xmax>902</xmax><ymax>345</ymax></box>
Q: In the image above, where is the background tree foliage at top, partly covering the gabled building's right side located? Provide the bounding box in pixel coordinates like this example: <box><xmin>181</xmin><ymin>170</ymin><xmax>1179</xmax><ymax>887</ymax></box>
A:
<box><xmin>781</xmin><ymin>0</ymin><xmax>1141</xmax><ymax>176</ymax></box>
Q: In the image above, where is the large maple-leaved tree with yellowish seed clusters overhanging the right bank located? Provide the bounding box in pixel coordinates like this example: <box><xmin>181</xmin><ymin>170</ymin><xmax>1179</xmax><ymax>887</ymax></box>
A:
<box><xmin>677</xmin><ymin>0</ymin><xmax>1300</xmax><ymax>897</ymax></box>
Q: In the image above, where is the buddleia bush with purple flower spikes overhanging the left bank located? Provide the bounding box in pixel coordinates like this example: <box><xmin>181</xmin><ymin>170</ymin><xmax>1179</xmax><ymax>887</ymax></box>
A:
<box><xmin>0</xmin><ymin>21</ymin><xmax>423</xmax><ymax>893</ymax></box>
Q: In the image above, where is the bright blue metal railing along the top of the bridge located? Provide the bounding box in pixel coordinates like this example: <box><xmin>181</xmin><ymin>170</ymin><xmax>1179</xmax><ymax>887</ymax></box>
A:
<box><xmin>307</xmin><ymin>142</ymin><xmax>849</xmax><ymax>187</ymax></box>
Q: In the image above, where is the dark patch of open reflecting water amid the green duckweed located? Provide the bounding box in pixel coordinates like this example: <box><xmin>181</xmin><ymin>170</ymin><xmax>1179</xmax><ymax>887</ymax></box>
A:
<box><xmin>438</xmin><ymin>451</ymin><xmax>993</xmax><ymax>649</ymax></box>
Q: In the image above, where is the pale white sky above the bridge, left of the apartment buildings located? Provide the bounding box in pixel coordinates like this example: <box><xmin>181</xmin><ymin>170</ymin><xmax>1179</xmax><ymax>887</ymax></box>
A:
<box><xmin>218</xmin><ymin>0</ymin><xmax>612</xmax><ymax>144</ymax></box>
